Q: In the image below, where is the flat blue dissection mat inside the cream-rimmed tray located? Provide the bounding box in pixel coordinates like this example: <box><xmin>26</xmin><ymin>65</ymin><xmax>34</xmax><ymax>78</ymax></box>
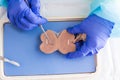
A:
<box><xmin>4</xmin><ymin>21</ymin><xmax>96</xmax><ymax>76</ymax></box>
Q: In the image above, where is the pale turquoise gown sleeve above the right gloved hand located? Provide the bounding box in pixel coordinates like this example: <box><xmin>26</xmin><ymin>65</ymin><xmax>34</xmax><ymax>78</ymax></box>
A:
<box><xmin>91</xmin><ymin>0</ymin><xmax>120</xmax><ymax>23</ymax></box>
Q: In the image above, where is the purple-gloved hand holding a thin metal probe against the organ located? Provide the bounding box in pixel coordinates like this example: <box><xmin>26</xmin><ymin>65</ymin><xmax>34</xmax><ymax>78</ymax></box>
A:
<box><xmin>7</xmin><ymin>0</ymin><xmax>47</xmax><ymax>30</ymax></box>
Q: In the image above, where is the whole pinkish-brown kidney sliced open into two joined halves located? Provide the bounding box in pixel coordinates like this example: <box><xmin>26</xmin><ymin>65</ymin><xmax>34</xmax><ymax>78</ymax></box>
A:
<box><xmin>40</xmin><ymin>30</ymin><xmax>76</xmax><ymax>54</ymax></box>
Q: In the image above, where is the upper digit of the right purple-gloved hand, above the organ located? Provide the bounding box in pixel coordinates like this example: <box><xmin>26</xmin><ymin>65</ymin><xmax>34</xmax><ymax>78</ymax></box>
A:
<box><xmin>67</xmin><ymin>24</ymin><xmax>83</xmax><ymax>34</ymax></box>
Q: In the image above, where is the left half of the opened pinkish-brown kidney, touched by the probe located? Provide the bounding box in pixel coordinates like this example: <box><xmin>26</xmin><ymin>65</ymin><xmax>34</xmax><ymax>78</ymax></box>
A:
<box><xmin>40</xmin><ymin>30</ymin><xmax>58</xmax><ymax>54</ymax></box>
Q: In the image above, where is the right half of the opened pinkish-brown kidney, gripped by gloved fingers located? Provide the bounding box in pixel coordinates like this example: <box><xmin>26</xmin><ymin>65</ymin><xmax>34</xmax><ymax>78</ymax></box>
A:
<box><xmin>58</xmin><ymin>30</ymin><xmax>76</xmax><ymax>54</ymax></box>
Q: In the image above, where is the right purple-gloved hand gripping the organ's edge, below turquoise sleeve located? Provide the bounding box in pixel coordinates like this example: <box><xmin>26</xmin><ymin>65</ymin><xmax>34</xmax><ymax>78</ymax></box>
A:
<box><xmin>66</xmin><ymin>14</ymin><xmax>114</xmax><ymax>58</ymax></box>
